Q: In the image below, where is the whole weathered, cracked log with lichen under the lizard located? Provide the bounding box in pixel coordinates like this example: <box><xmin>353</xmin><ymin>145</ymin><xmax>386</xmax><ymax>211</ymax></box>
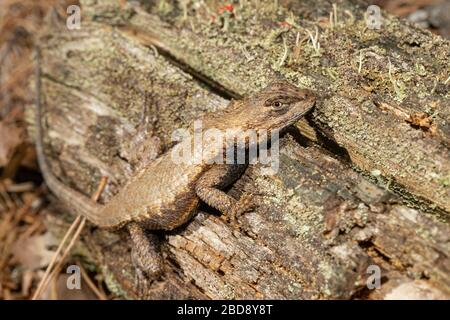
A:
<box><xmin>29</xmin><ymin>1</ymin><xmax>450</xmax><ymax>299</ymax></box>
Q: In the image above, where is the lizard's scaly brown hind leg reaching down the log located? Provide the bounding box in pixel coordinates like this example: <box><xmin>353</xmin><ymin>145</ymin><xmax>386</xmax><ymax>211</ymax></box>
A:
<box><xmin>127</xmin><ymin>222</ymin><xmax>164</xmax><ymax>297</ymax></box>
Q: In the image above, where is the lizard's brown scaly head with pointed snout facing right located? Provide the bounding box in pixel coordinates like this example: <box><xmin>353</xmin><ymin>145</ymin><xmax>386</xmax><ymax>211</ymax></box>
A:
<box><xmin>242</xmin><ymin>81</ymin><xmax>316</xmax><ymax>131</ymax></box>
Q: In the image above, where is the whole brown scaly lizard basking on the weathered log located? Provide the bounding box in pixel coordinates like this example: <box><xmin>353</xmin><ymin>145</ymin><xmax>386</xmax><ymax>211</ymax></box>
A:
<box><xmin>35</xmin><ymin>49</ymin><xmax>315</xmax><ymax>292</ymax></box>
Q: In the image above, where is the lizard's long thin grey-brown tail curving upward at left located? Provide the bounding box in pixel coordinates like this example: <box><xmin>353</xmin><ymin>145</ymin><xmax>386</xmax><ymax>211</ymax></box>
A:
<box><xmin>35</xmin><ymin>48</ymin><xmax>103</xmax><ymax>225</ymax></box>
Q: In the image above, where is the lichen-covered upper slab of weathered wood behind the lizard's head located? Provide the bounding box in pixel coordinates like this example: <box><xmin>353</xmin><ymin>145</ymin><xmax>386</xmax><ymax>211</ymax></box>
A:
<box><xmin>84</xmin><ymin>0</ymin><xmax>450</xmax><ymax>212</ymax></box>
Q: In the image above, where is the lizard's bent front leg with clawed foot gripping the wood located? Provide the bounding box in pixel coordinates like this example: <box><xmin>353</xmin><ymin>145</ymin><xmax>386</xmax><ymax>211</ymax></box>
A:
<box><xmin>195</xmin><ymin>164</ymin><xmax>251</xmax><ymax>226</ymax></box>
